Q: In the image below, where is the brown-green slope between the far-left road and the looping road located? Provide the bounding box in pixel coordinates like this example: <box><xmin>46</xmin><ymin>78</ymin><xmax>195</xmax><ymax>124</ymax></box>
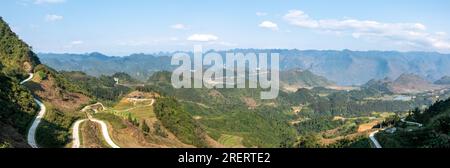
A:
<box><xmin>26</xmin><ymin>64</ymin><xmax>91</xmax><ymax>147</ymax></box>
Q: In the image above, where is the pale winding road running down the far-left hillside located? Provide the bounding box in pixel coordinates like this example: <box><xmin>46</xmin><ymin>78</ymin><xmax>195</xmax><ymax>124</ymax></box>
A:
<box><xmin>20</xmin><ymin>73</ymin><xmax>46</xmax><ymax>148</ymax></box>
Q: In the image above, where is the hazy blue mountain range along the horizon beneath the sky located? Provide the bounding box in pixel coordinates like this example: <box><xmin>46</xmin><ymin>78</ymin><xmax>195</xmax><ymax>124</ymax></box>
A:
<box><xmin>38</xmin><ymin>49</ymin><xmax>450</xmax><ymax>85</ymax></box>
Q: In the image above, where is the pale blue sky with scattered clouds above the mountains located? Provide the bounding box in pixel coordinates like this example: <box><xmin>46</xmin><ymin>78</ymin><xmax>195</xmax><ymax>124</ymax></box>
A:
<box><xmin>0</xmin><ymin>0</ymin><xmax>450</xmax><ymax>55</ymax></box>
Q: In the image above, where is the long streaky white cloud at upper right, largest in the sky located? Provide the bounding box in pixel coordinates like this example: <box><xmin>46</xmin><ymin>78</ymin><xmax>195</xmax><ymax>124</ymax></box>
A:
<box><xmin>283</xmin><ymin>10</ymin><xmax>450</xmax><ymax>50</ymax></box>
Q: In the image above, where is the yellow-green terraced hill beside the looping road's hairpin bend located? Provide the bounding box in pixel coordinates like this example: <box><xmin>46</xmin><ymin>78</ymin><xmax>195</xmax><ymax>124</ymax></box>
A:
<box><xmin>87</xmin><ymin>91</ymin><xmax>194</xmax><ymax>148</ymax></box>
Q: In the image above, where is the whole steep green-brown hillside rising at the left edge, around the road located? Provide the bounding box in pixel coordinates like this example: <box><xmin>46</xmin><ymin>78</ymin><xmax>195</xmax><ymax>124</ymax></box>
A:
<box><xmin>0</xmin><ymin>19</ymin><xmax>90</xmax><ymax>147</ymax></box>
